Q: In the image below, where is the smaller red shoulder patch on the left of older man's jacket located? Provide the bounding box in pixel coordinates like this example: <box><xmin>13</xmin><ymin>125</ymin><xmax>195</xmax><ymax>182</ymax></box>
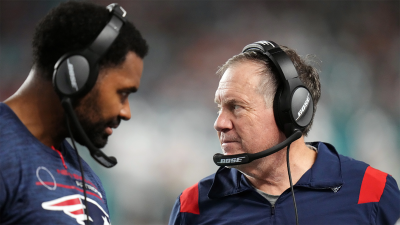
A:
<box><xmin>179</xmin><ymin>183</ymin><xmax>200</xmax><ymax>215</ymax></box>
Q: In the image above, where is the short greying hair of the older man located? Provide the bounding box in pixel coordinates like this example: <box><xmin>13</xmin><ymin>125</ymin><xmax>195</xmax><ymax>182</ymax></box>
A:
<box><xmin>217</xmin><ymin>46</ymin><xmax>321</xmax><ymax>136</ymax></box>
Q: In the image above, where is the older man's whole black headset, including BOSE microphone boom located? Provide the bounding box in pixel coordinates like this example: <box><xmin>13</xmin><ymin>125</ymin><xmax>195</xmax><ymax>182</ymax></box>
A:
<box><xmin>213</xmin><ymin>41</ymin><xmax>314</xmax><ymax>166</ymax></box>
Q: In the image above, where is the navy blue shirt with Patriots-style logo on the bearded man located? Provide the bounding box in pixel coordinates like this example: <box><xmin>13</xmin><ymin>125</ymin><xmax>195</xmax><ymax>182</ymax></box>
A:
<box><xmin>0</xmin><ymin>103</ymin><xmax>110</xmax><ymax>225</ymax></box>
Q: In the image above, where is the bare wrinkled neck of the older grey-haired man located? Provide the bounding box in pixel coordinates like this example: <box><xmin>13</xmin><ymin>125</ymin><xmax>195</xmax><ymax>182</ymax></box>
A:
<box><xmin>244</xmin><ymin>136</ymin><xmax>317</xmax><ymax>195</ymax></box>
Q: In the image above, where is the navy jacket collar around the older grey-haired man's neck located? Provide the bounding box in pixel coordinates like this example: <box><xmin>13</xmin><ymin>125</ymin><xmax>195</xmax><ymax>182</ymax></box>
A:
<box><xmin>208</xmin><ymin>142</ymin><xmax>343</xmax><ymax>199</ymax></box>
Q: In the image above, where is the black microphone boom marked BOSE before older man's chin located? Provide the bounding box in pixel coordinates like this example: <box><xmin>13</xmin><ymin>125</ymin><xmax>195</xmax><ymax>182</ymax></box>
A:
<box><xmin>213</xmin><ymin>130</ymin><xmax>302</xmax><ymax>166</ymax></box>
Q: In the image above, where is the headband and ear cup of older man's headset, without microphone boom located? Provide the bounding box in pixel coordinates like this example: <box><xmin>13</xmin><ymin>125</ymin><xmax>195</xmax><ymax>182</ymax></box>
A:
<box><xmin>242</xmin><ymin>41</ymin><xmax>314</xmax><ymax>137</ymax></box>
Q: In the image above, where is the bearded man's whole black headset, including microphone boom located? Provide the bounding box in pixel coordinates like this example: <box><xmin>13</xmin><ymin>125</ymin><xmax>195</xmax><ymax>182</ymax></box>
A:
<box><xmin>53</xmin><ymin>3</ymin><xmax>126</xmax><ymax>168</ymax></box>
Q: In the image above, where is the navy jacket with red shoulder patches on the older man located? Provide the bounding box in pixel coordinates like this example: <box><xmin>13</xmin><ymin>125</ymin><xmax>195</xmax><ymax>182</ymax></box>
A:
<box><xmin>169</xmin><ymin>142</ymin><xmax>400</xmax><ymax>225</ymax></box>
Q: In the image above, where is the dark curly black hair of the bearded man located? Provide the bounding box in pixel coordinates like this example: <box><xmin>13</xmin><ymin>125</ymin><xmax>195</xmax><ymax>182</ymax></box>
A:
<box><xmin>32</xmin><ymin>1</ymin><xmax>148</xmax><ymax>79</ymax></box>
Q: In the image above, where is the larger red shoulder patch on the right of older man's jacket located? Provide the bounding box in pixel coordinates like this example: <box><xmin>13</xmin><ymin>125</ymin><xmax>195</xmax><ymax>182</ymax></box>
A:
<box><xmin>358</xmin><ymin>166</ymin><xmax>388</xmax><ymax>204</ymax></box>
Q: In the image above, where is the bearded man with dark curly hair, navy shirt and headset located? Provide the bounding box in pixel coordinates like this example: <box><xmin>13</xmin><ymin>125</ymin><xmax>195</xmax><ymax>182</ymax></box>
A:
<box><xmin>0</xmin><ymin>1</ymin><xmax>148</xmax><ymax>225</ymax></box>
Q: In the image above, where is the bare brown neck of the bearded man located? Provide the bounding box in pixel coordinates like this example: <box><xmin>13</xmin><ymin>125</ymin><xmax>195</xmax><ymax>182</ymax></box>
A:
<box><xmin>4</xmin><ymin>68</ymin><xmax>66</xmax><ymax>148</ymax></box>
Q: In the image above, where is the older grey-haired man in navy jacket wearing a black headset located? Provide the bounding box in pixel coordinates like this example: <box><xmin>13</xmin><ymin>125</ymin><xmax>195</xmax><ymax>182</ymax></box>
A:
<box><xmin>169</xmin><ymin>41</ymin><xmax>400</xmax><ymax>225</ymax></box>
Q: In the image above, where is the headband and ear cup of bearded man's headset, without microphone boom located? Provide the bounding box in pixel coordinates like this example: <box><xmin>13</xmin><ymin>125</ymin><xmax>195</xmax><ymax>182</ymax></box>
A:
<box><xmin>53</xmin><ymin>3</ymin><xmax>126</xmax><ymax>98</ymax></box>
